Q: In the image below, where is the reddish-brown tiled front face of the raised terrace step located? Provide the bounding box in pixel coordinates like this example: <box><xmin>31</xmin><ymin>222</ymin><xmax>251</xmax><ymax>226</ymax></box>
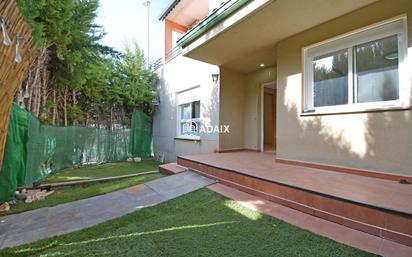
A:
<box><xmin>177</xmin><ymin>154</ymin><xmax>412</xmax><ymax>246</ymax></box>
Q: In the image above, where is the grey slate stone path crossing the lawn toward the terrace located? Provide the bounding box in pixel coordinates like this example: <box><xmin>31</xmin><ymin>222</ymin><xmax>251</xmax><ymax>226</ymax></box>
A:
<box><xmin>0</xmin><ymin>171</ymin><xmax>214</xmax><ymax>249</ymax></box>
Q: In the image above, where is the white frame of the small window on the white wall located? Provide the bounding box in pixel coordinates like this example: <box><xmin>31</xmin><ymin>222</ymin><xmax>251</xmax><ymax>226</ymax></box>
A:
<box><xmin>176</xmin><ymin>86</ymin><xmax>202</xmax><ymax>140</ymax></box>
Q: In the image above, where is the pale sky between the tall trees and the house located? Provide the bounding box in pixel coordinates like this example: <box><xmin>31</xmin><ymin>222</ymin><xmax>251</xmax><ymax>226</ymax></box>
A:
<box><xmin>96</xmin><ymin>0</ymin><xmax>170</xmax><ymax>63</ymax></box>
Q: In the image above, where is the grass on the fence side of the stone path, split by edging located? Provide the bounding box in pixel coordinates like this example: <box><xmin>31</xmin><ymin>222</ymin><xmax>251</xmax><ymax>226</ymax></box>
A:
<box><xmin>0</xmin><ymin>161</ymin><xmax>162</xmax><ymax>216</ymax></box>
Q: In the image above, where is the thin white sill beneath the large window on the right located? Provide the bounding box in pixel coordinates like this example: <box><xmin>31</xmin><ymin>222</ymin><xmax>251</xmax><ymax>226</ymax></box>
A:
<box><xmin>300</xmin><ymin>106</ymin><xmax>411</xmax><ymax>117</ymax></box>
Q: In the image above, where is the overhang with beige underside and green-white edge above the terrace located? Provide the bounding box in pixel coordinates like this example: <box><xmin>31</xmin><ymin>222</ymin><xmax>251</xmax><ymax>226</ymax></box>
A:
<box><xmin>179</xmin><ymin>0</ymin><xmax>377</xmax><ymax>72</ymax></box>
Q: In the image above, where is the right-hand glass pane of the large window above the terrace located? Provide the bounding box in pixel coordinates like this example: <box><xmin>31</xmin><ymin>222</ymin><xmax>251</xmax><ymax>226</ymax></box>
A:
<box><xmin>354</xmin><ymin>36</ymin><xmax>399</xmax><ymax>103</ymax></box>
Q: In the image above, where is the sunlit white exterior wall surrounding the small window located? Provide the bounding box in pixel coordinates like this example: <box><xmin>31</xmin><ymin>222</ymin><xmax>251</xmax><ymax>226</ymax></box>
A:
<box><xmin>153</xmin><ymin>55</ymin><xmax>219</xmax><ymax>162</ymax></box>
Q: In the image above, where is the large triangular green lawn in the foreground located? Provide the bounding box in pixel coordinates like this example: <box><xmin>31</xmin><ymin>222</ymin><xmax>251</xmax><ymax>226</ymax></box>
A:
<box><xmin>0</xmin><ymin>189</ymin><xmax>374</xmax><ymax>257</ymax></box>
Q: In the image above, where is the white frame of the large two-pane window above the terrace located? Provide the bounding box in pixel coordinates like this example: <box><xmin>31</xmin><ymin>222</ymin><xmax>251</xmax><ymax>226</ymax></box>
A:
<box><xmin>302</xmin><ymin>15</ymin><xmax>410</xmax><ymax>115</ymax></box>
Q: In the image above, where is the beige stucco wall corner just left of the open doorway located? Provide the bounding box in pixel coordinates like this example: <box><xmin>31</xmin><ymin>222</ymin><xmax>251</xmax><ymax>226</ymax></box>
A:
<box><xmin>219</xmin><ymin>67</ymin><xmax>276</xmax><ymax>150</ymax></box>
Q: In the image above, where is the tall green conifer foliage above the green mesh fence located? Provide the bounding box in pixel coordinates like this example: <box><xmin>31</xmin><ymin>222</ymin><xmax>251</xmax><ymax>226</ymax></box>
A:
<box><xmin>17</xmin><ymin>0</ymin><xmax>156</xmax><ymax>127</ymax></box>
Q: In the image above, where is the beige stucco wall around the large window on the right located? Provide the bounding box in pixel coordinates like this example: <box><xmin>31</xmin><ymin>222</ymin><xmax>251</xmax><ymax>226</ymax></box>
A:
<box><xmin>277</xmin><ymin>0</ymin><xmax>412</xmax><ymax>175</ymax></box>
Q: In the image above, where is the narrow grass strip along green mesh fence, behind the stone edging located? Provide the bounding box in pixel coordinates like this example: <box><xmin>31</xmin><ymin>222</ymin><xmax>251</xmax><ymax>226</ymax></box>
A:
<box><xmin>43</xmin><ymin>160</ymin><xmax>159</xmax><ymax>184</ymax></box>
